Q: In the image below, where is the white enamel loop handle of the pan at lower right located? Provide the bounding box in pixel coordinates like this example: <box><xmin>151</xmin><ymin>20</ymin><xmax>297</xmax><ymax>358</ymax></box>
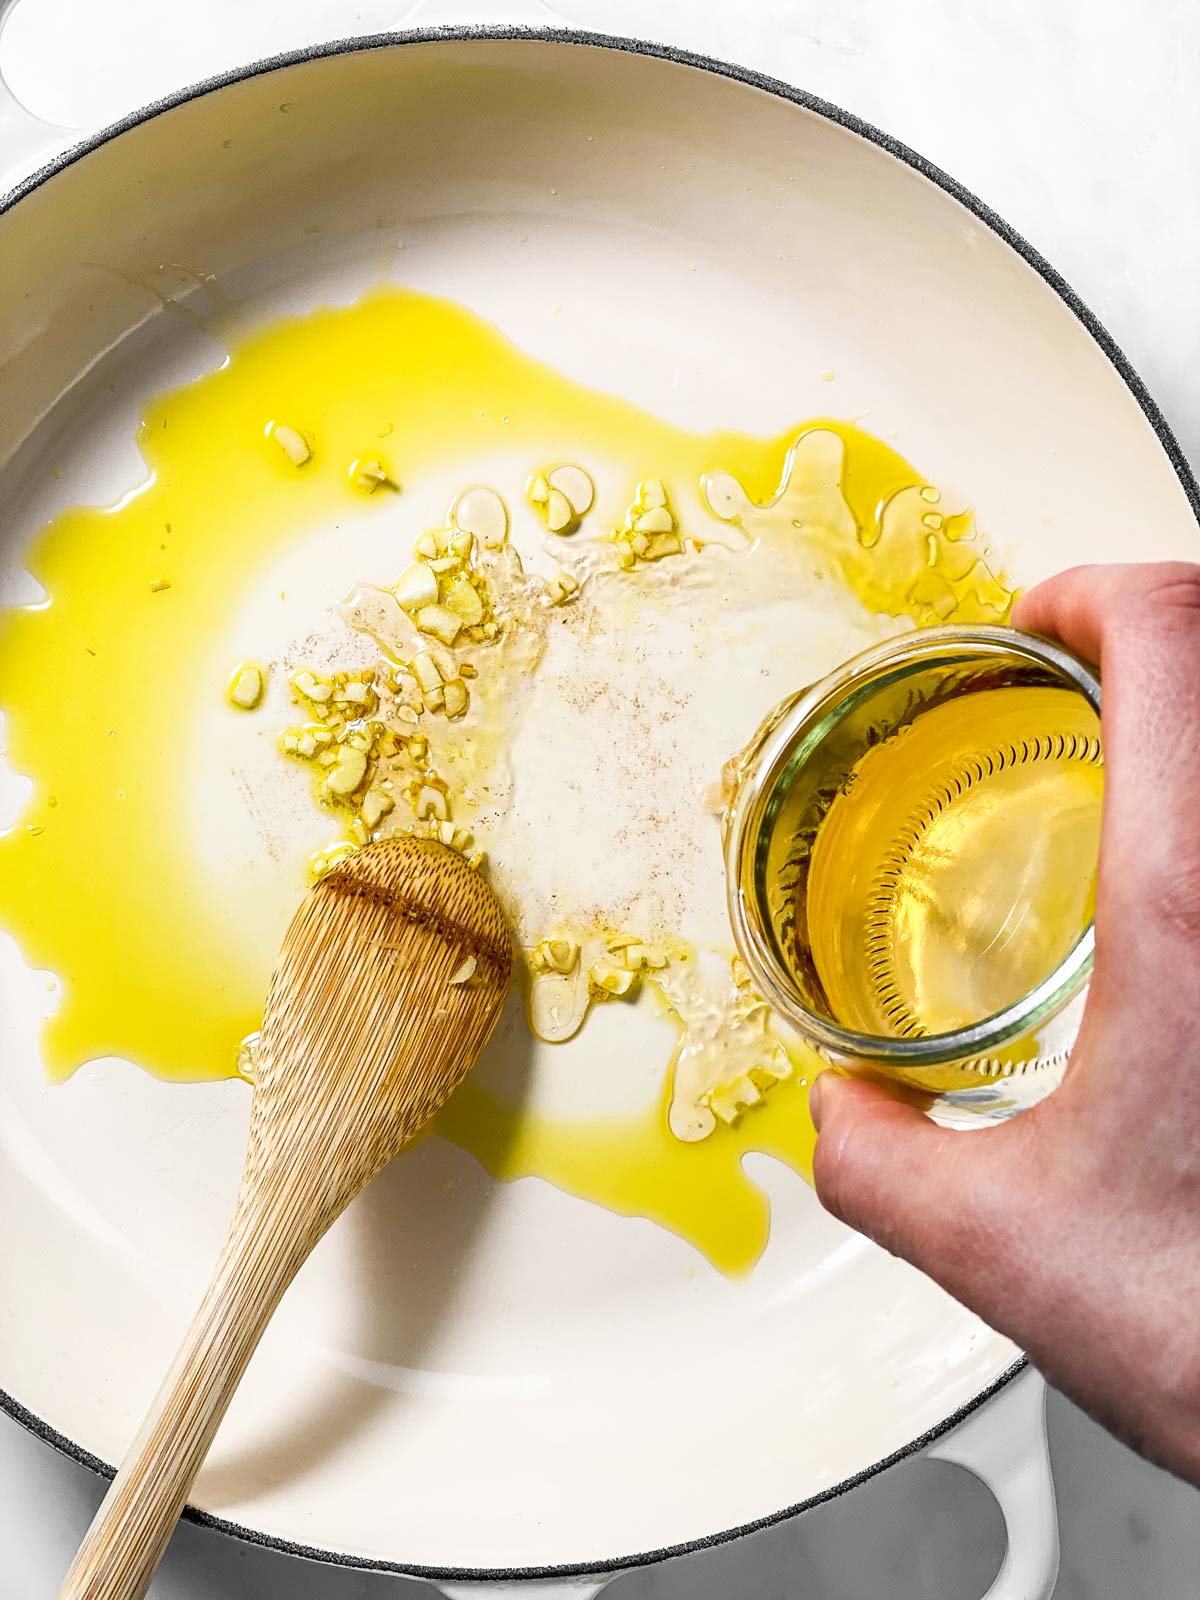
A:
<box><xmin>925</xmin><ymin>1366</ymin><xmax>1059</xmax><ymax>1600</ymax></box>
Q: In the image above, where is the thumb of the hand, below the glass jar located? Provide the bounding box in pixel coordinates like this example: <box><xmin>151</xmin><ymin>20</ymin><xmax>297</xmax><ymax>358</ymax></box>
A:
<box><xmin>810</xmin><ymin>1072</ymin><xmax>1032</xmax><ymax>1317</ymax></box>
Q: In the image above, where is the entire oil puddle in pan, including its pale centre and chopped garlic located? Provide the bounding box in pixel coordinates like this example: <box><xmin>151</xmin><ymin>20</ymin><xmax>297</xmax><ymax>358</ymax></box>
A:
<box><xmin>0</xmin><ymin>290</ymin><xmax>1013</xmax><ymax>1272</ymax></box>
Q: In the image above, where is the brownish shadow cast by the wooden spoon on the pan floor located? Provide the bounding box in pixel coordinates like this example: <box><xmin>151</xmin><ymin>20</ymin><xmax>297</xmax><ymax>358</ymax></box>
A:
<box><xmin>203</xmin><ymin>982</ymin><xmax>534</xmax><ymax>1516</ymax></box>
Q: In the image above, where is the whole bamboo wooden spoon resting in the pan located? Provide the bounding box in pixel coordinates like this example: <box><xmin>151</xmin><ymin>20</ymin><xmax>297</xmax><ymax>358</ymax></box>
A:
<box><xmin>59</xmin><ymin>838</ymin><xmax>512</xmax><ymax>1600</ymax></box>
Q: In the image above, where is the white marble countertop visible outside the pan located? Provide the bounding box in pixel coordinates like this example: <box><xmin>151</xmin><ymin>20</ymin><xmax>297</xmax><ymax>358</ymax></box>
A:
<box><xmin>0</xmin><ymin>0</ymin><xmax>1200</xmax><ymax>1600</ymax></box>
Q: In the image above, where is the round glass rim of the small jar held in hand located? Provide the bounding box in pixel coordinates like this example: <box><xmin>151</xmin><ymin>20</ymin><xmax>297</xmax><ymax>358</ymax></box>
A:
<box><xmin>725</xmin><ymin>624</ymin><xmax>1101</xmax><ymax>1069</ymax></box>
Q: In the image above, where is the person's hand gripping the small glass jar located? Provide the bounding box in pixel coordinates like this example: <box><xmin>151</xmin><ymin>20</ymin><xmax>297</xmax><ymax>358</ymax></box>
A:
<box><xmin>813</xmin><ymin>562</ymin><xmax>1200</xmax><ymax>1483</ymax></box>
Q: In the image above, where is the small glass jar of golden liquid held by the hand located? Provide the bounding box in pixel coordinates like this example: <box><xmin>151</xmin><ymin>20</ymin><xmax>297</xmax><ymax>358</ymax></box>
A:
<box><xmin>723</xmin><ymin>626</ymin><xmax>1102</xmax><ymax>1125</ymax></box>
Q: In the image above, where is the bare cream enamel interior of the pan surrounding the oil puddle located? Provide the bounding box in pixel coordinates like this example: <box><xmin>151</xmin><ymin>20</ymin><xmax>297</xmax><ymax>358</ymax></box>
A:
<box><xmin>0</xmin><ymin>40</ymin><xmax>1195</xmax><ymax>1568</ymax></box>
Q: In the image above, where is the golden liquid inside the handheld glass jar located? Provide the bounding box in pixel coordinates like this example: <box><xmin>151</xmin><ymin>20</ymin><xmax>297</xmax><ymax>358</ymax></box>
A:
<box><xmin>802</xmin><ymin>686</ymin><xmax>1102</xmax><ymax>1038</ymax></box>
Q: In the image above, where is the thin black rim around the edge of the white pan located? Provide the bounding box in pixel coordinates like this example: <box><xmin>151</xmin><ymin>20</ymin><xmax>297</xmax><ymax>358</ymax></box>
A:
<box><xmin>0</xmin><ymin>26</ymin><xmax>1200</xmax><ymax>1582</ymax></box>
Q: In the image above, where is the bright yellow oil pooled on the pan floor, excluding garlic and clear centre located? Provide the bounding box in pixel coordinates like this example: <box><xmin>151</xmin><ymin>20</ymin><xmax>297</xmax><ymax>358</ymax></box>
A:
<box><xmin>0</xmin><ymin>290</ymin><xmax>1011</xmax><ymax>1272</ymax></box>
